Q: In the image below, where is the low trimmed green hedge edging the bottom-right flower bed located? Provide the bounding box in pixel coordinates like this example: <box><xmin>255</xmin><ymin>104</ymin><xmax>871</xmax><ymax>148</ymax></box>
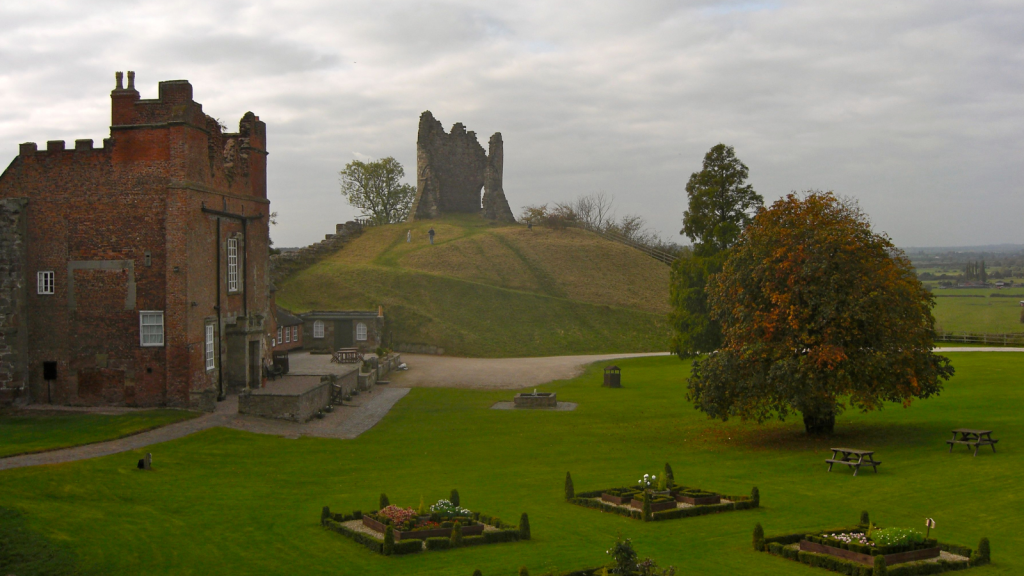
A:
<box><xmin>764</xmin><ymin>526</ymin><xmax>980</xmax><ymax>576</ymax></box>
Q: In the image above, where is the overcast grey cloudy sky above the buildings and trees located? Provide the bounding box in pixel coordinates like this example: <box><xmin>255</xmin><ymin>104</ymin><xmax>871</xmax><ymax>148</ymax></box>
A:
<box><xmin>0</xmin><ymin>0</ymin><xmax>1024</xmax><ymax>246</ymax></box>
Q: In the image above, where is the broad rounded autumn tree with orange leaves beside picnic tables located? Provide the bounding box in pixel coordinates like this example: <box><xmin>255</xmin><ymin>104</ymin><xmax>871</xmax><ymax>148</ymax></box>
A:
<box><xmin>688</xmin><ymin>192</ymin><xmax>953</xmax><ymax>434</ymax></box>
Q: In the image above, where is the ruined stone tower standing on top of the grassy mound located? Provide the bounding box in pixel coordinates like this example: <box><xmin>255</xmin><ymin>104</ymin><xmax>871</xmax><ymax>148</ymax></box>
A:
<box><xmin>410</xmin><ymin>111</ymin><xmax>515</xmax><ymax>222</ymax></box>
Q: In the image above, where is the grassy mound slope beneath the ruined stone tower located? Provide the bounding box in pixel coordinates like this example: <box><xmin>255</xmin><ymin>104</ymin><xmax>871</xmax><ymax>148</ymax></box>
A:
<box><xmin>276</xmin><ymin>216</ymin><xmax>670</xmax><ymax>357</ymax></box>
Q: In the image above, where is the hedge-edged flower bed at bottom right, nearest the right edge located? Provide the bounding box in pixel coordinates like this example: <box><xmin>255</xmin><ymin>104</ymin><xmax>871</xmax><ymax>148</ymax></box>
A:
<box><xmin>762</xmin><ymin>518</ymin><xmax>988</xmax><ymax>576</ymax></box>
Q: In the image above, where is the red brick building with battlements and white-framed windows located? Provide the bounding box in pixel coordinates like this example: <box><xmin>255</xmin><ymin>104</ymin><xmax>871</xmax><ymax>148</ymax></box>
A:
<box><xmin>0</xmin><ymin>72</ymin><xmax>272</xmax><ymax>409</ymax></box>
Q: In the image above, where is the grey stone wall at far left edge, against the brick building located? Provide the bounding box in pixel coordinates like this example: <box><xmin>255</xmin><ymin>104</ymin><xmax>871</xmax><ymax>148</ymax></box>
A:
<box><xmin>0</xmin><ymin>198</ymin><xmax>28</xmax><ymax>406</ymax></box>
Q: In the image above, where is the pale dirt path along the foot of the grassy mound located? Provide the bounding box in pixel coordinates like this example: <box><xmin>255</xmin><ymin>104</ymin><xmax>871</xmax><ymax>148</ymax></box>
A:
<box><xmin>389</xmin><ymin>353</ymin><xmax>669</xmax><ymax>389</ymax></box>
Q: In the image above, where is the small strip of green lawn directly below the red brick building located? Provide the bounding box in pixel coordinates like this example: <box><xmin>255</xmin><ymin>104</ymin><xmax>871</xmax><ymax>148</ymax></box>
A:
<box><xmin>0</xmin><ymin>410</ymin><xmax>199</xmax><ymax>457</ymax></box>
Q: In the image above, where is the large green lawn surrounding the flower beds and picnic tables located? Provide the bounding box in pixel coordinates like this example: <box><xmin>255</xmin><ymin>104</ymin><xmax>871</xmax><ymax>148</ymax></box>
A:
<box><xmin>0</xmin><ymin>353</ymin><xmax>1011</xmax><ymax>576</ymax></box>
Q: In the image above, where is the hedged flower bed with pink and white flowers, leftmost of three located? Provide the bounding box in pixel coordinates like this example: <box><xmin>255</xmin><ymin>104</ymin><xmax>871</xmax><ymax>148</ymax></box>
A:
<box><xmin>321</xmin><ymin>501</ymin><xmax>529</xmax><ymax>556</ymax></box>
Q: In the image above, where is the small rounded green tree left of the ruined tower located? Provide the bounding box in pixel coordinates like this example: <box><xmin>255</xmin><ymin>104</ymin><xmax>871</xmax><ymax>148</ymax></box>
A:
<box><xmin>340</xmin><ymin>156</ymin><xmax>416</xmax><ymax>224</ymax></box>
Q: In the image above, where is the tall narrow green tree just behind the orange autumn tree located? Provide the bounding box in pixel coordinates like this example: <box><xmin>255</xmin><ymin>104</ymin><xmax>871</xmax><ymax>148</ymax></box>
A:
<box><xmin>670</xmin><ymin>143</ymin><xmax>764</xmax><ymax>358</ymax></box>
